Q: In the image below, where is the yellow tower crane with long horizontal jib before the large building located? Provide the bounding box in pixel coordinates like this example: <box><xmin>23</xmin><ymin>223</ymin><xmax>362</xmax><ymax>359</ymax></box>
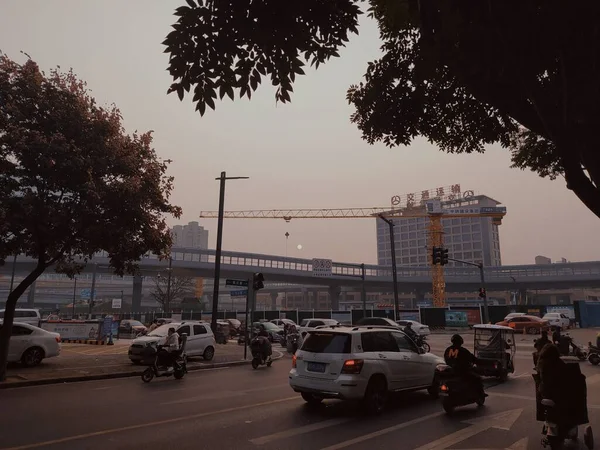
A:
<box><xmin>200</xmin><ymin>199</ymin><xmax>506</xmax><ymax>307</ymax></box>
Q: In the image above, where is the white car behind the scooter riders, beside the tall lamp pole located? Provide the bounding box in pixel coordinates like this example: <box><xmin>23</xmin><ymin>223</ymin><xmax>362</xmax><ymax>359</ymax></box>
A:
<box><xmin>129</xmin><ymin>321</ymin><xmax>216</xmax><ymax>364</ymax></box>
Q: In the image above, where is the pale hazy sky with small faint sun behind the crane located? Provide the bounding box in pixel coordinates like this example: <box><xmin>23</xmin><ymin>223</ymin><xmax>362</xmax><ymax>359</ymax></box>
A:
<box><xmin>0</xmin><ymin>0</ymin><xmax>600</xmax><ymax>264</ymax></box>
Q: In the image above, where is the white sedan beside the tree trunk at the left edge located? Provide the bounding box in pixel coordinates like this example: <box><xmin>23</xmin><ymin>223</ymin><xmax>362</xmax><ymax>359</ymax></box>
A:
<box><xmin>0</xmin><ymin>321</ymin><xmax>60</xmax><ymax>367</ymax></box>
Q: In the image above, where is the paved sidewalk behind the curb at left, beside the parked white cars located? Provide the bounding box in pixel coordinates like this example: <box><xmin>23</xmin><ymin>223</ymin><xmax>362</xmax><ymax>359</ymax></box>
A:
<box><xmin>0</xmin><ymin>340</ymin><xmax>266</xmax><ymax>389</ymax></box>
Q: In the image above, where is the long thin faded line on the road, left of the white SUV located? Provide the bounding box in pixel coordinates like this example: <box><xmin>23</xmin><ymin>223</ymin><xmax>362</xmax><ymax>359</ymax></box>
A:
<box><xmin>0</xmin><ymin>395</ymin><xmax>301</xmax><ymax>450</ymax></box>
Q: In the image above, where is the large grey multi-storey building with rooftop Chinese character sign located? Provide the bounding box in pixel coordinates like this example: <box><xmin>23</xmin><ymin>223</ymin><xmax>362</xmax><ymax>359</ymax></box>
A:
<box><xmin>376</xmin><ymin>185</ymin><xmax>502</xmax><ymax>267</ymax></box>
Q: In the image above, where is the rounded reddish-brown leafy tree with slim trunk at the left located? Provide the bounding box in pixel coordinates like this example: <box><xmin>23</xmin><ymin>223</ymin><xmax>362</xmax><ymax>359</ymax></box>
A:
<box><xmin>0</xmin><ymin>54</ymin><xmax>181</xmax><ymax>381</ymax></box>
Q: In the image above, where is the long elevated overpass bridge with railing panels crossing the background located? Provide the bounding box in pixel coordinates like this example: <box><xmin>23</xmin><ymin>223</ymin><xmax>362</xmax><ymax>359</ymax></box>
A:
<box><xmin>0</xmin><ymin>248</ymin><xmax>600</xmax><ymax>296</ymax></box>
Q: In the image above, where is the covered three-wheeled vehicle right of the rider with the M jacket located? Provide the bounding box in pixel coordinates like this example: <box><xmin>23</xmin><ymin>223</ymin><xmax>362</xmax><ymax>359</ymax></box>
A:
<box><xmin>473</xmin><ymin>324</ymin><xmax>517</xmax><ymax>381</ymax></box>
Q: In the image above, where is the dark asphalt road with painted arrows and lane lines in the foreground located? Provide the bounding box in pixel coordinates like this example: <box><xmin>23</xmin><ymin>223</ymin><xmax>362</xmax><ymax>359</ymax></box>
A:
<box><xmin>0</xmin><ymin>336</ymin><xmax>600</xmax><ymax>450</ymax></box>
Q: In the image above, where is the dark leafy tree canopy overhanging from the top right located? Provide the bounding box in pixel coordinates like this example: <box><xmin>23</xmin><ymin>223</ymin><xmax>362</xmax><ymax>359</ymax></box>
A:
<box><xmin>164</xmin><ymin>0</ymin><xmax>600</xmax><ymax>217</ymax></box>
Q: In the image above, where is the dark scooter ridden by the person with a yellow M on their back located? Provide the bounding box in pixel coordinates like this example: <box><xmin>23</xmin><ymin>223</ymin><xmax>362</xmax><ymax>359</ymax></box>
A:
<box><xmin>436</xmin><ymin>364</ymin><xmax>486</xmax><ymax>414</ymax></box>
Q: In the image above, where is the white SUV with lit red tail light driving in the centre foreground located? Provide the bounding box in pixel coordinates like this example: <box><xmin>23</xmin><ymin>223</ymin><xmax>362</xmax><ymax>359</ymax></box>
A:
<box><xmin>289</xmin><ymin>326</ymin><xmax>444</xmax><ymax>414</ymax></box>
